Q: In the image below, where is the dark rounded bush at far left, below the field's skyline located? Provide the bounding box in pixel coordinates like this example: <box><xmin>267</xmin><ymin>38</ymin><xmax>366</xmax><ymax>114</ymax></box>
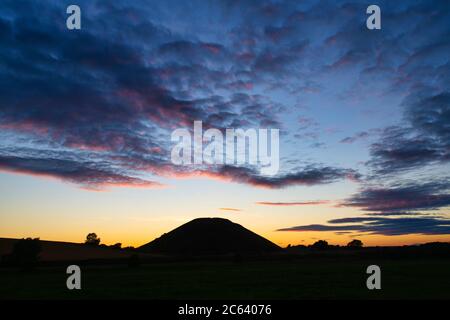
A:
<box><xmin>5</xmin><ymin>238</ymin><xmax>42</xmax><ymax>270</ymax></box>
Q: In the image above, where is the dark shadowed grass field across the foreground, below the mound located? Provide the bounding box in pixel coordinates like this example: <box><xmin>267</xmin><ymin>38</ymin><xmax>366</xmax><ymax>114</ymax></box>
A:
<box><xmin>0</xmin><ymin>258</ymin><xmax>450</xmax><ymax>299</ymax></box>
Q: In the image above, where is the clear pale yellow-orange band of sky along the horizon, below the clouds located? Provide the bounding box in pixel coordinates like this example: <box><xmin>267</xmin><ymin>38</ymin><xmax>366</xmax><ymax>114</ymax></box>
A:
<box><xmin>0</xmin><ymin>173</ymin><xmax>450</xmax><ymax>247</ymax></box>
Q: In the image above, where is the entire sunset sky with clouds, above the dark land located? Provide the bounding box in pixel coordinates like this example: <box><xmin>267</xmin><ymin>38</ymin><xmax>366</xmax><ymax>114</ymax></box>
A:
<box><xmin>0</xmin><ymin>0</ymin><xmax>450</xmax><ymax>246</ymax></box>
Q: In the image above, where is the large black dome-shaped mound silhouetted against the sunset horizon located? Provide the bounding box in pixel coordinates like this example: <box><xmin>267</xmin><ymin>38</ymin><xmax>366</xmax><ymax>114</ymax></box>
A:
<box><xmin>139</xmin><ymin>218</ymin><xmax>281</xmax><ymax>254</ymax></box>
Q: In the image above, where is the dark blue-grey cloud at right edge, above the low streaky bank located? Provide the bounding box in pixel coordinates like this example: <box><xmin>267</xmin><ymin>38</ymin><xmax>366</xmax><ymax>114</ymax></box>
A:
<box><xmin>369</xmin><ymin>92</ymin><xmax>450</xmax><ymax>175</ymax></box>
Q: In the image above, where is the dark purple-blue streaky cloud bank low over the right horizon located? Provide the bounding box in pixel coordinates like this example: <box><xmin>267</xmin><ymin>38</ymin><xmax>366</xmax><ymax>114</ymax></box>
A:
<box><xmin>278</xmin><ymin>178</ymin><xmax>450</xmax><ymax>235</ymax></box>
